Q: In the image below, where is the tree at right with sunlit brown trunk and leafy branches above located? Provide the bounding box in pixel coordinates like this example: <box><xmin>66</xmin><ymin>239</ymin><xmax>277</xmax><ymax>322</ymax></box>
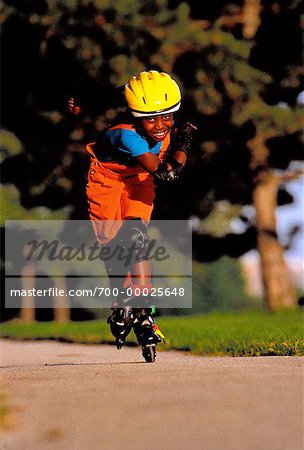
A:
<box><xmin>166</xmin><ymin>2</ymin><xmax>303</xmax><ymax>310</ymax></box>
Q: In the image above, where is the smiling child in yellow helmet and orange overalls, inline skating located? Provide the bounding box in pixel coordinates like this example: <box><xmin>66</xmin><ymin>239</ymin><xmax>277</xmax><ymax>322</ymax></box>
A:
<box><xmin>86</xmin><ymin>70</ymin><xmax>195</xmax><ymax>362</ymax></box>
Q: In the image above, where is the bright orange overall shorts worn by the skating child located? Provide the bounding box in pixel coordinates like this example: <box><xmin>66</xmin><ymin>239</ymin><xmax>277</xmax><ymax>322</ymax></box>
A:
<box><xmin>86</xmin><ymin>159</ymin><xmax>155</xmax><ymax>244</ymax></box>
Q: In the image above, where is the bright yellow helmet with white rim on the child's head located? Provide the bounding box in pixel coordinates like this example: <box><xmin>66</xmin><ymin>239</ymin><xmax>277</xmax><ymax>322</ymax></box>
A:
<box><xmin>124</xmin><ymin>70</ymin><xmax>181</xmax><ymax>117</ymax></box>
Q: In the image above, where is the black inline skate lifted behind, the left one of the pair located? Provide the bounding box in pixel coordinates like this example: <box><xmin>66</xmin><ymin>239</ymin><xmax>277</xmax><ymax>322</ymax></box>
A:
<box><xmin>107</xmin><ymin>306</ymin><xmax>134</xmax><ymax>350</ymax></box>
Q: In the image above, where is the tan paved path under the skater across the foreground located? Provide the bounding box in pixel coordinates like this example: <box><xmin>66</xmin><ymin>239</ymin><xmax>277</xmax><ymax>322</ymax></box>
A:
<box><xmin>1</xmin><ymin>340</ymin><xmax>304</xmax><ymax>450</ymax></box>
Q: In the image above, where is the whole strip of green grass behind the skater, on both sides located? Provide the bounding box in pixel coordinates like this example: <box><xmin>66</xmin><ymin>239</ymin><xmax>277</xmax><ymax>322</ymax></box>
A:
<box><xmin>0</xmin><ymin>311</ymin><xmax>304</xmax><ymax>356</ymax></box>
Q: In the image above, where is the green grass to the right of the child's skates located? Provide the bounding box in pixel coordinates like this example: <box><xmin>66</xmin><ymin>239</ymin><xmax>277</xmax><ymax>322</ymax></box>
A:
<box><xmin>159</xmin><ymin>311</ymin><xmax>304</xmax><ymax>356</ymax></box>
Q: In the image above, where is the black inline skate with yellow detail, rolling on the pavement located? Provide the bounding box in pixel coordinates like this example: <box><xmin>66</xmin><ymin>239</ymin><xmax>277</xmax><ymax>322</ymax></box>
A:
<box><xmin>133</xmin><ymin>308</ymin><xmax>165</xmax><ymax>363</ymax></box>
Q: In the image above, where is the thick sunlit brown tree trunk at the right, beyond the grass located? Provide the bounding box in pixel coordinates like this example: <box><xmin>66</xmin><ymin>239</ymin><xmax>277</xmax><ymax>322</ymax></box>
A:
<box><xmin>253</xmin><ymin>168</ymin><xmax>297</xmax><ymax>311</ymax></box>
